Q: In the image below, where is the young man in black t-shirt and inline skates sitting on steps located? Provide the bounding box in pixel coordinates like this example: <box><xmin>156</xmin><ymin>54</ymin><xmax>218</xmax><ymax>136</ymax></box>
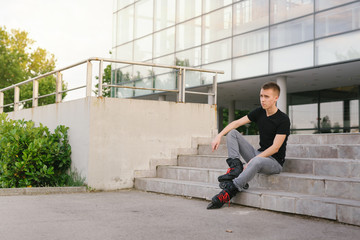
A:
<box><xmin>207</xmin><ymin>82</ymin><xmax>290</xmax><ymax>209</ymax></box>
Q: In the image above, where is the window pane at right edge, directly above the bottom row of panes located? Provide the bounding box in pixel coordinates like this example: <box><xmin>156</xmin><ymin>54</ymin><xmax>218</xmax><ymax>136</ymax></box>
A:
<box><xmin>315</xmin><ymin>3</ymin><xmax>360</xmax><ymax>38</ymax></box>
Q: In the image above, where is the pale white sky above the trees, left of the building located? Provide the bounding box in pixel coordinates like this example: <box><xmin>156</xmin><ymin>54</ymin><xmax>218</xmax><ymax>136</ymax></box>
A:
<box><xmin>0</xmin><ymin>0</ymin><xmax>113</xmax><ymax>99</ymax></box>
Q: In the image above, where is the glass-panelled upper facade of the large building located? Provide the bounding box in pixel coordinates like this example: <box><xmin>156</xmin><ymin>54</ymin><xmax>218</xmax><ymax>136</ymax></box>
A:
<box><xmin>113</xmin><ymin>0</ymin><xmax>360</xmax><ymax>97</ymax></box>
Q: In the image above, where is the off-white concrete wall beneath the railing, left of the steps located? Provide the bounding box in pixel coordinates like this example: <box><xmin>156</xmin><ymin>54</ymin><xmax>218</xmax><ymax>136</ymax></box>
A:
<box><xmin>9</xmin><ymin>97</ymin><xmax>217</xmax><ymax>190</ymax></box>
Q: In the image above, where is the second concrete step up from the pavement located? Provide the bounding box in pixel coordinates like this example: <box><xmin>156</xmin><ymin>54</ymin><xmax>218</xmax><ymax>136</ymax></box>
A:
<box><xmin>157</xmin><ymin>166</ymin><xmax>360</xmax><ymax>201</ymax></box>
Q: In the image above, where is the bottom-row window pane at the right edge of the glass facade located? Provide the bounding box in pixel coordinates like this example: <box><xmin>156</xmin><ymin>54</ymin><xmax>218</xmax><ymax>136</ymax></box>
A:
<box><xmin>315</xmin><ymin>31</ymin><xmax>360</xmax><ymax>65</ymax></box>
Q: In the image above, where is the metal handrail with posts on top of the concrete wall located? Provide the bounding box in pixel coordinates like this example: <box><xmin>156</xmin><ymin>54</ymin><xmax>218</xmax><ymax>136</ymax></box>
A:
<box><xmin>0</xmin><ymin>57</ymin><xmax>224</xmax><ymax>113</ymax></box>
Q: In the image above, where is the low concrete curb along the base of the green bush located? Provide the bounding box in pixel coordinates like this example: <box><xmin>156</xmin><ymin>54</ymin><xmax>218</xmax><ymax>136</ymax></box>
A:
<box><xmin>0</xmin><ymin>187</ymin><xmax>87</xmax><ymax>196</ymax></box>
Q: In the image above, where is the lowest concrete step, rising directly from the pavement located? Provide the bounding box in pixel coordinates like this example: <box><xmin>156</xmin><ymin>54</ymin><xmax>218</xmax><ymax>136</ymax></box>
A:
<box><xmin>135</xmin><ymin>178</ymin><xmax>360</xmax><ymax>226</ymax></box>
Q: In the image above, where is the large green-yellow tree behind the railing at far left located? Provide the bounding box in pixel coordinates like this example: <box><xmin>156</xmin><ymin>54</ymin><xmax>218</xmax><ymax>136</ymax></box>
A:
<box><xmin>0</xmin><ymin>27</ymin><xmax>67</xmax><ymax>111</ymax></box>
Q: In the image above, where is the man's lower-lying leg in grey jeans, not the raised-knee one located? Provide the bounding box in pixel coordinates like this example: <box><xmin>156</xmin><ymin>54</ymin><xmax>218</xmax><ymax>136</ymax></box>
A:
<box><xmin>233</xmin><ymin>155</ymin><xmax>282</xmax><ymax>191</ymax></box>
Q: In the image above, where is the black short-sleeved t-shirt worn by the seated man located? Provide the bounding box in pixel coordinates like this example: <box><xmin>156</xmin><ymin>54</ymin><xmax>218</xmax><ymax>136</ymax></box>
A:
<box><xmin>248</xmin><ymin>107</ymin><xmax>290</xmax><ymax>166</ymax></box>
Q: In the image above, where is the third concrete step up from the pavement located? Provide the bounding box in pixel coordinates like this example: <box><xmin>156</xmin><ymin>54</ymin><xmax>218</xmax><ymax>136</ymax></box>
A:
<box><xmin>178</xmin><ymin>155</ymin><xmax>360</xmax><ymax>178</ymax></box>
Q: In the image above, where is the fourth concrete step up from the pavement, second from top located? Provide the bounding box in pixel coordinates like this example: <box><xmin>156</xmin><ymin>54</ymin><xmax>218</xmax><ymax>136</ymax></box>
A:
<box><xmin>198</xmin><ymin>144</ymin><xmax>360</xmax><ymax>160</ymax></box>
